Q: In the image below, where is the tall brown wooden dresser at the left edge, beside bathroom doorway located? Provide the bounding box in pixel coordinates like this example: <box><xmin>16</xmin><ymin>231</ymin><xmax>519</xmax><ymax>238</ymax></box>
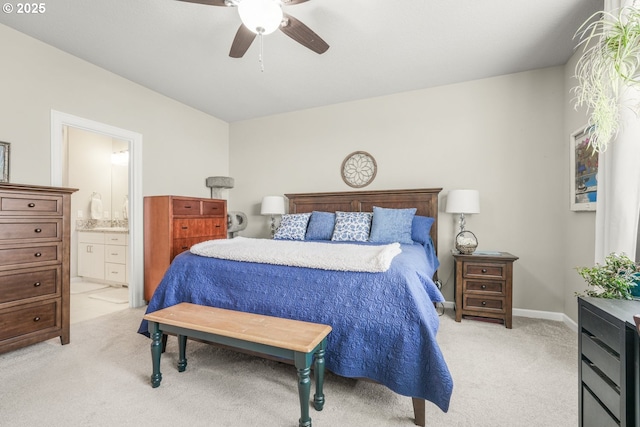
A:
<box><xmin>0</xmin><ymin>183</ymin><xmax>77</xmax><ymax>353</ymax></box>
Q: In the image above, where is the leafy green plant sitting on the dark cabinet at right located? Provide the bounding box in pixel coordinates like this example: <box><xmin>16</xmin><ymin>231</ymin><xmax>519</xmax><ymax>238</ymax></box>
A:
<box><xmin>576</xmin><ymin>253</ymin><xmax>640</xmax><ymax>300</ymax></box>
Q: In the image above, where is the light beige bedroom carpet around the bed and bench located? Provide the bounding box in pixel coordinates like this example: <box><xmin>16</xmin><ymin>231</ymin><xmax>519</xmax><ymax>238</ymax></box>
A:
<box><xmin>0</xmin><ymin>308</ymin><xmax>578</xmax><ymax>427</ymax></box>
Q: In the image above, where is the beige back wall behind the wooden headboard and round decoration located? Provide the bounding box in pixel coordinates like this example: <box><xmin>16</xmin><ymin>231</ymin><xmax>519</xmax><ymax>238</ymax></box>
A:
<box><xmin>230</xmin><ymin>67</ymin><xmax>568</xmax><ymax>312</ymax></box>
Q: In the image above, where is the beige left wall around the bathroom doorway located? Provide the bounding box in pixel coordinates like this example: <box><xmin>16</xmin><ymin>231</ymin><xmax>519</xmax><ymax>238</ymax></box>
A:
<box><xmin>0</xmin><ymin>25</ymin><xmax>229</xmax><ymax>197</ymax></box>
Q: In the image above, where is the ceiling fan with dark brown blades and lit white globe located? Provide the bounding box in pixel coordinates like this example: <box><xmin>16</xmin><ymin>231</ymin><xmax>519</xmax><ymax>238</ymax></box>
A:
<box><xmin>179</xmin><ymin>0</ymin><xmax>329</xmax><ymax>58</ymax></box>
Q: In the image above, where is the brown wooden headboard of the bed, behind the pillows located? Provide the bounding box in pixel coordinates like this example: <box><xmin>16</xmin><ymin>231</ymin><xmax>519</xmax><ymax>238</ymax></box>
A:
<box><xmin>285</xmin><ymin>188</ymin><xmax>442</xmax><ymax>254</ymax></box>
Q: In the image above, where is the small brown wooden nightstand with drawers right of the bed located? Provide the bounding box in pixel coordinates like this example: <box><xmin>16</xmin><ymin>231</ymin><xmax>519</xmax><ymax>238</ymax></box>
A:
<box><xmin>453</xmin><ymin>252</ymin><xmax>518</xmax><ymax>329</ymax></box>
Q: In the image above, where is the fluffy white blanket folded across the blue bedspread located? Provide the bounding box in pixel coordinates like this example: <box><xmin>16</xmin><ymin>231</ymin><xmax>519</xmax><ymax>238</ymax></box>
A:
<box><xmin>191</xmin><ymin>237</ymin><xmax>402</xmax><ymax>273</ymax></box>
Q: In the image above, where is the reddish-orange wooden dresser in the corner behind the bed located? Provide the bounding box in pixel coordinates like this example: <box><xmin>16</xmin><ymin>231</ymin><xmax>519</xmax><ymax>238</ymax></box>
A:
<box><xmin>144</xmin><ymin>196</ymin><xmax>227</xmax><ymax>302</ymax></box>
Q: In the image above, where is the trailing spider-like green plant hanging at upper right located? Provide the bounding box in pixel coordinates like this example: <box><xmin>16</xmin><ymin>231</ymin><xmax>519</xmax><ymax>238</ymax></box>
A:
<box><xmin>573</xmin><ymin>6</ymin><xmax>640</xmax><ymax>152</ymax></box>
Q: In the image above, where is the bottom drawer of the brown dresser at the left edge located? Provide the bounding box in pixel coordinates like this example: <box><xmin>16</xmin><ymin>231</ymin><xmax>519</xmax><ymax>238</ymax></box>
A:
<box><xmin>0</xmin><ymin>299</ymin><xmax>60</xmax><ymax>341</ymax></box>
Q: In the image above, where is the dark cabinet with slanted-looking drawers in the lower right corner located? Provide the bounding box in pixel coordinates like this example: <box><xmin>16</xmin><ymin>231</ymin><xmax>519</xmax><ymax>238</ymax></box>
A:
<box><xmin>578</xmin><ymin>297</ymin><xmax>640</xmax><ymax>427</ymax></box>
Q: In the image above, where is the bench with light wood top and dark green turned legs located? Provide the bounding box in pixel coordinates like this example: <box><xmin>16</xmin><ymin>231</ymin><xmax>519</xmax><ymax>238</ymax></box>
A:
<box><xmin>144</xmin><ymin>303</ymin><xmax>331</xmax><ymax>427</ymax></box>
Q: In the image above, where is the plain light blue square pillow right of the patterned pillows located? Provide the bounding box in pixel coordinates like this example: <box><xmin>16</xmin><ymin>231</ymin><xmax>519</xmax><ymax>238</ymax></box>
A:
<box><xmin>369</xmin><ymin>206</ymin><xmax>416</xmax><ymax>244</ymax></box>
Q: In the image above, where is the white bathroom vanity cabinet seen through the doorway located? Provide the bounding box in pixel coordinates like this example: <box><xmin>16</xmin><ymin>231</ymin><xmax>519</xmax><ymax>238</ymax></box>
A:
<box><xmin>78</xmin><ymin>231</ymin><xmax>129</xmax><ymax>285</ymax></box>
